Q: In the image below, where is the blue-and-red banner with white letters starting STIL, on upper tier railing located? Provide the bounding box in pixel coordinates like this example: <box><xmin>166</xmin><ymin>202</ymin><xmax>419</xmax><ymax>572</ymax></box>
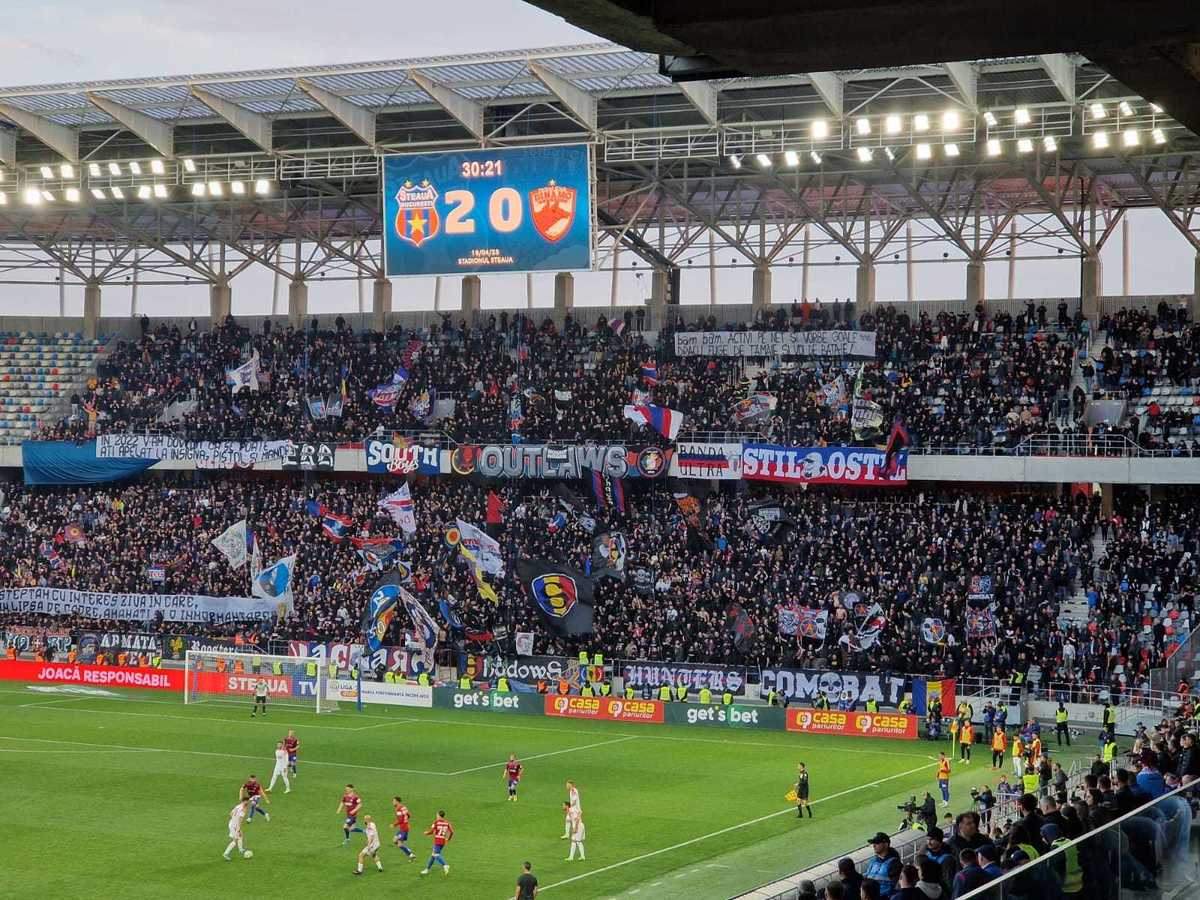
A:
<box><xmin>742</xmin><ymin>444</ymin><xmax>908</xmax><ymax>487</ymax></box>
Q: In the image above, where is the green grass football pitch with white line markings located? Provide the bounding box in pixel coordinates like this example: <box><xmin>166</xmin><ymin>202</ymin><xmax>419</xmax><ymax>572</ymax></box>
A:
<box><xmin>0</xmin><ymin>685</ymin><xmax>1092</xmax><ymax>900</ymax></box>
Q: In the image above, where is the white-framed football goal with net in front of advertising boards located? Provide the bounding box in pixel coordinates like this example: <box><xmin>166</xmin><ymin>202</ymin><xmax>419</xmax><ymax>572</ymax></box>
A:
<box><xmin>184</xmin><ymin>650</ymin><xmax>359</xmax><ymax>713</ymax></box>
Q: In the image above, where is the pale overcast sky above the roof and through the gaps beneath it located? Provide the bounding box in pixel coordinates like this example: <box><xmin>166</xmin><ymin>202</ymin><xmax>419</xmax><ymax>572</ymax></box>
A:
<box><xmin>0</xmin><ymin>0</ymin><xmax>1194</xmax><ymax>316</ymax></box>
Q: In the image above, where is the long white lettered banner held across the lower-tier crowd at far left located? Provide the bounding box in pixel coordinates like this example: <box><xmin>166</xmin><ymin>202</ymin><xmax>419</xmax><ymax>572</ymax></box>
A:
<box><xmin>0</xmin><ymin>588</ymin><xmax>288</xmax><ymax>622</ymax></box>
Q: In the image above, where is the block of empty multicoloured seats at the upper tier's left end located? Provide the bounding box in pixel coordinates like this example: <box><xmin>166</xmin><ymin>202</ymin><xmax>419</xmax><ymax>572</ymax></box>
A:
<box><xmin>0</xmin><ymin>331</ymin><xmax>103</xmax><ymax>444</ymax></box>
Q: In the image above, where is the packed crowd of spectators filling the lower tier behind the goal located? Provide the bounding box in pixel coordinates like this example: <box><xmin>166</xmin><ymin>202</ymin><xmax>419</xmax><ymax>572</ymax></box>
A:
<box><xmin>0</xmin><ymin>473</ymin><xmax>1200</xmax><ymax>695</ymax></box>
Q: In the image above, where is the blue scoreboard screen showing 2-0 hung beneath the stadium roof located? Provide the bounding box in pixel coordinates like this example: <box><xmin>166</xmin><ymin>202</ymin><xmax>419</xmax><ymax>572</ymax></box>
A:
<box><xmin>383</xmin><ymin>144</ymin><xmax>592</xmax><ymax>276</ymax></box>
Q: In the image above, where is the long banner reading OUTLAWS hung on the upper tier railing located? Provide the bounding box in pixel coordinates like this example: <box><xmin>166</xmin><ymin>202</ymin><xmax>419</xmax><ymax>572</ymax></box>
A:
<box><xmin>450</xmin><ymin>444</ymin><xmax>672</xmax><ymax>479</ymax></box>
